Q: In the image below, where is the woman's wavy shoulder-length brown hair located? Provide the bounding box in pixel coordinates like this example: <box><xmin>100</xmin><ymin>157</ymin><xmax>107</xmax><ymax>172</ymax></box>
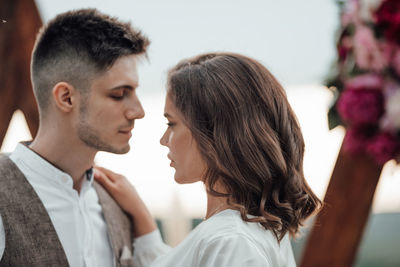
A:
<box><xmin>167</xmin><ymin>53</ymin><xmax>322</xmax><ymax>241</ymax></box>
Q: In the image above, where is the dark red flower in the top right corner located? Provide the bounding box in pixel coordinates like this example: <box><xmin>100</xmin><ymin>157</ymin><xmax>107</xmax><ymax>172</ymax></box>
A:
<box><xmin>375</xmin><ymin>0</ymin><xmax>400</xmax><ymax>44</ymax></box>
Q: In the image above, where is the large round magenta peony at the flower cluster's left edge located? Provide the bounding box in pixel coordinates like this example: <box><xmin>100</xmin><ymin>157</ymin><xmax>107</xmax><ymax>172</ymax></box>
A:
<box><xmin>336</xmin><ymin>89</ymin><xmax>384</xmax><ymax>125</ymax></box>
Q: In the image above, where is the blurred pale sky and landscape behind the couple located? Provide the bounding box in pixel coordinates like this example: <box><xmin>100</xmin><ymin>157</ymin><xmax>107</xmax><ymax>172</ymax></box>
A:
<box><xmin>0</xmin><ymin>0</ymin><xmax>400</xmax><ymax>266</ymax></box>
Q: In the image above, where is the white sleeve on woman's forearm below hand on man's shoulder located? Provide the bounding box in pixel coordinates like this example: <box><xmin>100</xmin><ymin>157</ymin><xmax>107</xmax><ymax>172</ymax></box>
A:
<box><xmin>133</xmin><ymin>229</ymin><xmax>171</xmax><ymax>267</ymax></box>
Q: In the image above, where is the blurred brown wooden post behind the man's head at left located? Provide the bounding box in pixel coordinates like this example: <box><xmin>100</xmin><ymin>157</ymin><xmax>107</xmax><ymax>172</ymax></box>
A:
<box><xmin>0</xmin><ymin>0</ymin><xmax>42</xmax><ymax>146</ymax></box>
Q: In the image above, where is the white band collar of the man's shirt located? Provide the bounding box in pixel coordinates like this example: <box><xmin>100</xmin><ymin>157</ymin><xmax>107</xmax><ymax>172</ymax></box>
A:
<box><xmin>12</xmin><ymin>142</ymin><xmax>94</xmax><ymax>191</ymax></box>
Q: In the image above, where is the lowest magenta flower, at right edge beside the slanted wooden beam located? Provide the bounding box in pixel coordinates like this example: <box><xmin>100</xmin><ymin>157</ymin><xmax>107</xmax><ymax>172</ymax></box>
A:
<box><xmin>367</xmin><ymin>132</ymin><xmax>400</xmax><ymax>165</ymax></box>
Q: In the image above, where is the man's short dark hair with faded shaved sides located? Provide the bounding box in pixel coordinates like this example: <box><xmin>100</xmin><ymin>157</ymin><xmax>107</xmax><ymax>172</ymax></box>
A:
<box><xmin>31</xmin><ymin>9</ymin><xmax>149</xmax><ymax>114</ymax></box>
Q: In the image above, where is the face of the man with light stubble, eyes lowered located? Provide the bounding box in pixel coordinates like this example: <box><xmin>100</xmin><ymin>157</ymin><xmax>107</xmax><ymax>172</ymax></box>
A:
<box><xmin>77</xmin><ymin>55</ymin><xmax>144</xmax><ymax>154</ymax></box>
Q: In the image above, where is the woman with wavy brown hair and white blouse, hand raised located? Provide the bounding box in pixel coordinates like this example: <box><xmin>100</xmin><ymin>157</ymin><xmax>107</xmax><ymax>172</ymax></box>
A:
<box><xmin>96</xmin><ymin>53</ymin><xmax>321</xmax><ymax>267</ymax></box>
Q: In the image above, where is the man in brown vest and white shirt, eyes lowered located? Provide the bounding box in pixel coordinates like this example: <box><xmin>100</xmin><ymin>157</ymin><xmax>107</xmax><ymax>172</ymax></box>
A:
<box><xmin>0</xmin><ymin>9</ymin><xmax>154</xmax><ymax>267</ymax></box>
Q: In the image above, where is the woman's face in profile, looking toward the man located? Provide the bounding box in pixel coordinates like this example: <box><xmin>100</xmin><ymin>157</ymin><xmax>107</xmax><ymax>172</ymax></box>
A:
<box><xmin>160</xmin><ymin>96</ymin><xmax>206</xmax><ymax>184</ymax></box>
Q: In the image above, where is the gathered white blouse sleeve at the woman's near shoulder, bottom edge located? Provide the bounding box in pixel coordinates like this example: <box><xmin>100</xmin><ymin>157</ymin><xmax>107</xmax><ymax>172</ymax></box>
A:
<box><xmin>198</xmin><ymin>236</ymin><xmax>272</xmax><ymax>267</ymax></box>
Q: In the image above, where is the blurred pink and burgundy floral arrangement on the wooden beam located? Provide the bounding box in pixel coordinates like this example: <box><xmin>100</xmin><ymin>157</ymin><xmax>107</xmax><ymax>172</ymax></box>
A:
<box><xmin>327</xmin><ymin>0</ymin><xmax>400</xmax><ymax>165</ymax></box>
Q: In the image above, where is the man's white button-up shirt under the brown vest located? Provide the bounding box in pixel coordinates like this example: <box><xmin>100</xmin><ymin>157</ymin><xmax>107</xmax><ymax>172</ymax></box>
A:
<box><xmin>0</xmin><ymin>144</ymin><xmax>115</xmax><ymax>267</ymax></box>
